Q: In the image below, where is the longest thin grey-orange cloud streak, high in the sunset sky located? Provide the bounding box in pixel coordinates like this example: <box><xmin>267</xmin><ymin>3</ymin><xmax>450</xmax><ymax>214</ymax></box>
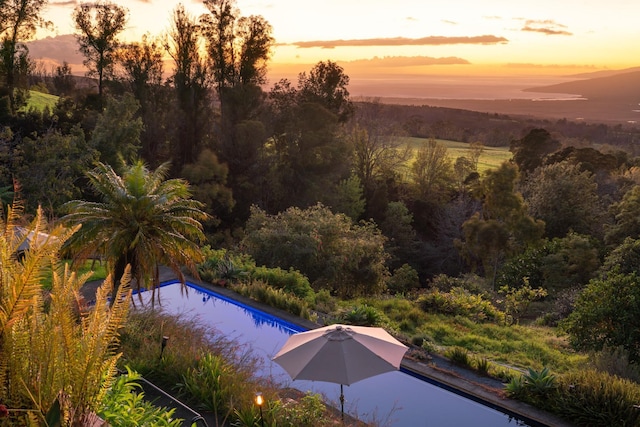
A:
<box><xmin>291</xmin><ymin>35</ymin><xmax>509</xmax><ymax>49</ymax></box>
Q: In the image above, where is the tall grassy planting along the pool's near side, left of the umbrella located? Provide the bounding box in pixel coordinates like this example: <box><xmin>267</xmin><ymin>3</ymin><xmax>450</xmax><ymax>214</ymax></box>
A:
<box><xmin>121</xmin><ymin>307</ymin><xmax>262</xmax><ymax>422</ymax></box>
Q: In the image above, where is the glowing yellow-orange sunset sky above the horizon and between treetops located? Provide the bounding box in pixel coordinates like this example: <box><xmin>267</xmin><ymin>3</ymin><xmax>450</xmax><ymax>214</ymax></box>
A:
<box><xmin>32</xmin><ymin>0</ymin><xmax>640</xmax><ymax>99</ymax></box>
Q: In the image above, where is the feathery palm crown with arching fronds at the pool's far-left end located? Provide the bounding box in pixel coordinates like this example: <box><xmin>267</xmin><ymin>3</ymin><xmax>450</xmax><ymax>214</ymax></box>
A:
<box><xmin>60</xmin><ymin>161</ymin><xmax>209</xmax><ymax>300</ymax></box>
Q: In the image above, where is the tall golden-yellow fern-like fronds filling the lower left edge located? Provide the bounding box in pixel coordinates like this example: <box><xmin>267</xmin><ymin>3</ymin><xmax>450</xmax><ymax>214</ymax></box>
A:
<box><xmin>0</xmin><ymin>208</ymin><xmax>131</xmax><ymax>425</ymax></box>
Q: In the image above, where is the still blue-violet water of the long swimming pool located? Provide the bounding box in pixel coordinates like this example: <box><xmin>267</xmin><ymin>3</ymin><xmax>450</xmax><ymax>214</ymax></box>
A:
<box><xmin>143</xmin><ymin>283</ymin><xmax>529</xmax><ymax>427</ymax></box>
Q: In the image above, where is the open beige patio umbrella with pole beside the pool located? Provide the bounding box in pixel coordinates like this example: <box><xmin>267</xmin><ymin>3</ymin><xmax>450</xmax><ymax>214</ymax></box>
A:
<box><xmin>273</xmin><ymin>325</ymin><xmax>407</xmax><ymax>417</ymax></box>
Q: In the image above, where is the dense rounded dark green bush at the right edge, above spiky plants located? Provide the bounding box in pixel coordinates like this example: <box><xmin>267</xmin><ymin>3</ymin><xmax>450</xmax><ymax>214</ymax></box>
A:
<box><xmin>562</xmin><ymin>270</ymin><xmax>640</xmax><ymax>363</ymax></box>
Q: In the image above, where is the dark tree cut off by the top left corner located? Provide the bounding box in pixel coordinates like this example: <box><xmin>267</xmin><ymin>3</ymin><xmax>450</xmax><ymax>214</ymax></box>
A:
<box><xmin>0</xmin><ymin>0</ymin><xmax>49</xmax><ymax>113</ymax></box>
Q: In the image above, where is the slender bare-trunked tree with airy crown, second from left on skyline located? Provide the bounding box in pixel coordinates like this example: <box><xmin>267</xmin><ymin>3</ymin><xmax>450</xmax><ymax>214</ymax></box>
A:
<box><xmin>73</xmin><ymin>0</ymin><xmax>128</xmax><ymax>99</ymax></box>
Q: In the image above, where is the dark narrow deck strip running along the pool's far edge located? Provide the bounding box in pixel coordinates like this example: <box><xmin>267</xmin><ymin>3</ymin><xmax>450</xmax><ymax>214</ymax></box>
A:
<box><xmin>81</xmin><ymin>269</ymin><xmax>572</xmax><ymax>427</ymax></box>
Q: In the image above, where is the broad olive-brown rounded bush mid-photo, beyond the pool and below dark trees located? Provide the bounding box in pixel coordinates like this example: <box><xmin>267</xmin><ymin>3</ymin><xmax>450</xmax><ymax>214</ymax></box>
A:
<box><xmin>242</xmin><ymin>204</ymin><xmax>388</xmax><ymax>296</ymax></box>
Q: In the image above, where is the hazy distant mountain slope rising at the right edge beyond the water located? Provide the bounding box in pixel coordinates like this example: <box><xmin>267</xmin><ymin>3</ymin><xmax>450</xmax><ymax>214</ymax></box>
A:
<box><xmin>524</xmin><ymin>68</ymin><xmax>640</xmax><ymax>100</ymax></box>
